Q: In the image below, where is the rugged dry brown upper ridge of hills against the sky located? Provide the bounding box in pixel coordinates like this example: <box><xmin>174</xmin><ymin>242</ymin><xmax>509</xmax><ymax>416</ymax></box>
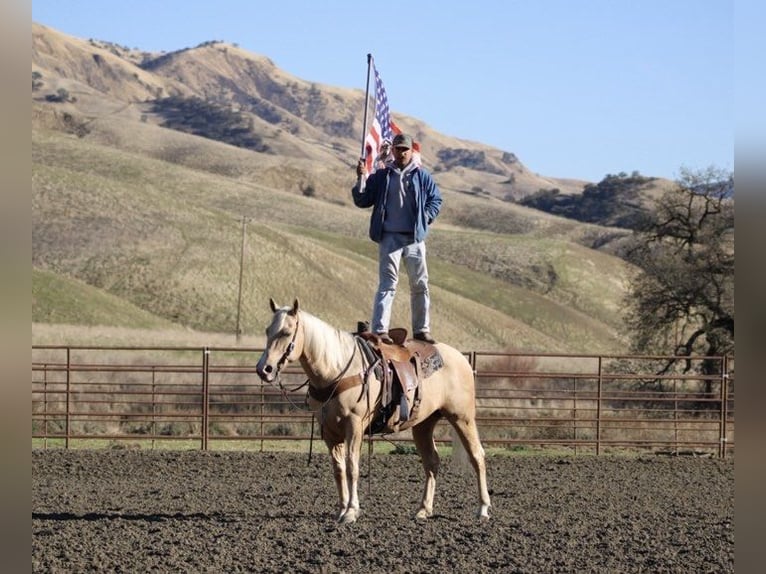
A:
<box><xmin>32</xmin><ymin>22</ymin><xmax>587</xmax><ymax>198</ymax></box>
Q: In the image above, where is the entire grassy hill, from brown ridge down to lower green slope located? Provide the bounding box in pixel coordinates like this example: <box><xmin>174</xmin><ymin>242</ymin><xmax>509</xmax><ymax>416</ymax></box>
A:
<box><xmin>32</xmin><ymin>24</ymin><xmax>644</xmax><ymax>352</ymax></box>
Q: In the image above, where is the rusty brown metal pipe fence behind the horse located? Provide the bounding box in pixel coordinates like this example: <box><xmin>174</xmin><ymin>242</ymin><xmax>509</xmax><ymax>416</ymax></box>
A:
<box><xmin>32</xmin><ymin>346</ymin><xmax>734</xmax><ymax>458</ymax></box>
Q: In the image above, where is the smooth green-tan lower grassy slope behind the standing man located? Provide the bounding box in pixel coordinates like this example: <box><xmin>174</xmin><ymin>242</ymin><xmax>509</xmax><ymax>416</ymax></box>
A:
<box><xmin>32</xmin><ymin>124</ymin><xmax>627</xmax><ymax>351</ymax></box>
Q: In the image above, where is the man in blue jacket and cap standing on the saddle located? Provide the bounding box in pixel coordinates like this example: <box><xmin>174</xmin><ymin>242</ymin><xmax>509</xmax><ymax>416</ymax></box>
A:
<box><xmin>351</xmin><ymin>134</ymin><xmax>442</xmax><ymax>343</ymax></box>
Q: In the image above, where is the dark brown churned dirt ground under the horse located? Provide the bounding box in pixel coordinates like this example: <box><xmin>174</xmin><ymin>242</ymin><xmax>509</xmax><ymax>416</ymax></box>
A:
<box><xmin>32</xmin><ymin>450</ymin><xmax>734</xmax><ymax>574</ymax></box>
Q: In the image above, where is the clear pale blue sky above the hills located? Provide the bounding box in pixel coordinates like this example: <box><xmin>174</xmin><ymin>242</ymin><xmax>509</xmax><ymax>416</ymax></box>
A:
<box><xmin>32</xmin><ymin>0</ymin><xmax>735</xmax><ymax>181</ymax></box>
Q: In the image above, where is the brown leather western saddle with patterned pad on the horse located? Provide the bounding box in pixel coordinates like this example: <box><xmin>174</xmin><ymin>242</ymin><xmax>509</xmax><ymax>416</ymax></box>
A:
<box><xmin>357</xmin><ymin>328</ymin><xmax>444</xmax><ymax>434</ymax></box>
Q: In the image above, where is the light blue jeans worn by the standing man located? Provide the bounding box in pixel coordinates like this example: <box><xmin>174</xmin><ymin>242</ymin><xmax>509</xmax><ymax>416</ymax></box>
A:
<box><xmin>370</xmin><ymin>233</ymin><xmax>431</xmax><ymax>334</ymax></box>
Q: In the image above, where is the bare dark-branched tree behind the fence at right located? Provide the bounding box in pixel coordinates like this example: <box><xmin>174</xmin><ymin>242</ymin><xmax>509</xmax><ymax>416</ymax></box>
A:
<box><xmin>626</xmin><ymin>167</ymin><xmax>734</xmax><ymax>374</ymax></box>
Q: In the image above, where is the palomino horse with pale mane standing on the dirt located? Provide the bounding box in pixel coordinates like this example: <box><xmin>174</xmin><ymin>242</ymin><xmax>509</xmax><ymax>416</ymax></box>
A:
<box><xmin>256</xmin><ymin>298</ymin><xmax>491</xmax><ymax>523</ymax></box>
